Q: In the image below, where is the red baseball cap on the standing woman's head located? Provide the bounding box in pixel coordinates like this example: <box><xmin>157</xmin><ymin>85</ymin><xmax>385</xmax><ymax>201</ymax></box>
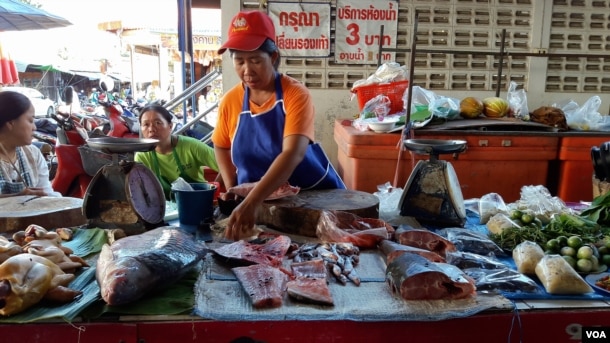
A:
<box><xmin>218</xmin><ymin>11</ymin><xmax>275</xmax><ymax>54</ymax></box>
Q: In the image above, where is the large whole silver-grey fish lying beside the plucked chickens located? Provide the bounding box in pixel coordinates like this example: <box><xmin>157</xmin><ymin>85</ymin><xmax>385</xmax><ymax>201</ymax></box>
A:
<box><xmin>96</xmin><ymin>226</ymin><xmax>208</xmax><ymax>305</ymax></box>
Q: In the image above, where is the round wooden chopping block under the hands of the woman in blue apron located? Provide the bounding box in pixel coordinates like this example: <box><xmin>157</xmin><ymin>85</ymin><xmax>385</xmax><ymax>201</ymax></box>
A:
<box><xmin>257</xmin><ymin>189</ymin><xmax>379</xmax><ymax>237</ymax></box>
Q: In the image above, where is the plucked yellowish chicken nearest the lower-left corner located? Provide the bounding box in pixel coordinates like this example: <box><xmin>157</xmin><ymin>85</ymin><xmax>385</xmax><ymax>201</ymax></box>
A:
<box><xmin>0</xmin><ymin>253</ymin><xmax>81</xmax><ymax>316</ymax></box>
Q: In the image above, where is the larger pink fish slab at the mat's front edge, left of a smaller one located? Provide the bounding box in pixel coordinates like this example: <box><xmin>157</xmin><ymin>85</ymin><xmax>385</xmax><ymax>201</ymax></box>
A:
<box><xmin>231</xmin><ymin>264</ymin><xmax>288</xmax><ymax>308</ymax></box>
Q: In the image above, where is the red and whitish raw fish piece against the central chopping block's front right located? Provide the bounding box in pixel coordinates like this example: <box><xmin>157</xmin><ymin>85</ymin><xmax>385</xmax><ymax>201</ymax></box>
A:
<box><xmin>316</xmin><ymin>210</ymin><xmax>394</xmax><ymax>249</ymax></box>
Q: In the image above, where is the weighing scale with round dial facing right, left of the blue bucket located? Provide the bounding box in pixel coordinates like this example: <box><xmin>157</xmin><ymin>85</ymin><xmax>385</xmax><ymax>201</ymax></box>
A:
<box><xmin>82</xmin><ymin>137</ymin><xmax>165</xmax><ymax>235</ymax></box>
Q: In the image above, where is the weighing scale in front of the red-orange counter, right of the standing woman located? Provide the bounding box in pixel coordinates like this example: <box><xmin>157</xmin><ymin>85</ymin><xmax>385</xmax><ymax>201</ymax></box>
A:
<box><xmin>399</xmin><ymin>139</ymin><xmax>467</xmax><ymax>227</ymax></box>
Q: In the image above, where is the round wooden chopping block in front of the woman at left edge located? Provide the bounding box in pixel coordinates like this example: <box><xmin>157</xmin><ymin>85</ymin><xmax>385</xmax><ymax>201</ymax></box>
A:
<box><xmin>0</xmin><ymin>195</ymin><xmax>87</xmax><ymax>233</ymax></box>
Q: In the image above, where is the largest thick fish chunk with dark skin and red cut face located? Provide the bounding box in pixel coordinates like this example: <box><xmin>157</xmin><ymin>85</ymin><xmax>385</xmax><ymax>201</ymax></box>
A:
<box><xmin>386</xmin><ymin>253</ymin><xmax>476</xmax><ymax>300</ymax></box>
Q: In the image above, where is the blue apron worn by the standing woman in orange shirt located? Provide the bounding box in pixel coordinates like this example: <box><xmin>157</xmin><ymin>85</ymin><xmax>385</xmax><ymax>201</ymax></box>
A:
<box><xmin>231</xmin><ymin>73</ymin><xmax>345</xmax><ymax>190</ymax></box>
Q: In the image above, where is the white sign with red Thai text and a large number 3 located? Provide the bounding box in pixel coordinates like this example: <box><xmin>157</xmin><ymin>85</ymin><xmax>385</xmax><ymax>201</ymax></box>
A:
<box><xmin>335</xmin><ymin>0</ymin><xmax>398</xmax><ymax>64</ymax></box>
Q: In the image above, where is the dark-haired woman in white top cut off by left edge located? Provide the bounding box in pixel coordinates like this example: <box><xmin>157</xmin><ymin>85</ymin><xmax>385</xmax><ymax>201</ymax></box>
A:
<box><xmin>0</xmin><ymin>90</ymin><xmax>61</xmax><ymax>197</ymax></box>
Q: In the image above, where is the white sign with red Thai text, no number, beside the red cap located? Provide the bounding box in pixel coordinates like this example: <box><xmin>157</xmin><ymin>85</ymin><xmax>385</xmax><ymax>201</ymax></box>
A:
<box><xmin>268</xmin><ymin>1</ymin><xmax>330</xmax><ymax>57</ymax></box>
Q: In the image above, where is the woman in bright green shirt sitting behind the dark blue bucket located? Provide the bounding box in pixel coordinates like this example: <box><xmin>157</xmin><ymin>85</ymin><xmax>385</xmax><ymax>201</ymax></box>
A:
<box><xmin>135</xmin><ymin>104</ymin><xmax>218</xmax><ymax>199</ymax></box>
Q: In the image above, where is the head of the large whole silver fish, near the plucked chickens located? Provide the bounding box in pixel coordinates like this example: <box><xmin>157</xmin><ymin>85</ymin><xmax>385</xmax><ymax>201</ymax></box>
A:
<box><xmin>98</xmin><ymin>257</ymin><xmax>156</xmax><ymax>305</ymax></box>
